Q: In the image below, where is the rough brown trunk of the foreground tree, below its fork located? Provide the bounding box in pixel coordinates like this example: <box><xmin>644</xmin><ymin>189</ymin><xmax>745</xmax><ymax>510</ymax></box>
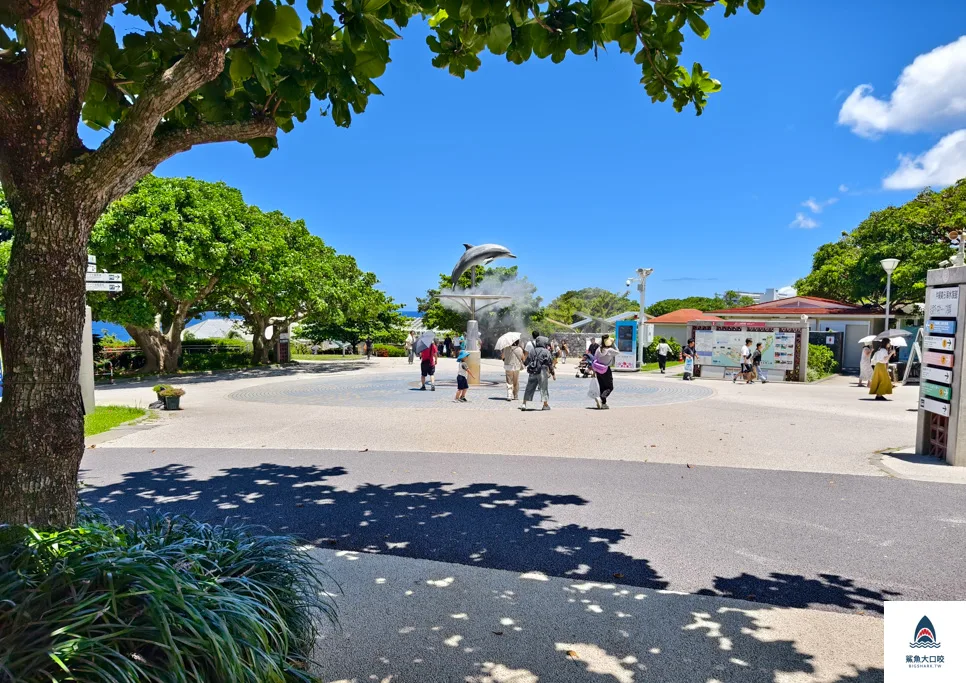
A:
<box><xmin>0</xmin><ymin>200</ymin><xmax>92</xmax><ymax>527</ymax></box>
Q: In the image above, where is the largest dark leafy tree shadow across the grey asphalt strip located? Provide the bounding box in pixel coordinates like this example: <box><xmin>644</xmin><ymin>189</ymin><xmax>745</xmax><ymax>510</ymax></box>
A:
<box><xmin>81</xmin><ymin>464</ymin><xmax>667</xmax><ymax>588</ymax></box>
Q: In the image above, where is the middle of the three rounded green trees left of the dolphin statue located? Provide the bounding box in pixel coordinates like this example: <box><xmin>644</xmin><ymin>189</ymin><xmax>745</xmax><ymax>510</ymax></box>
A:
<box><xmin>217</xmin><ymin>212</ymin><xmax>345</xmax><ymax>363</ymax></box>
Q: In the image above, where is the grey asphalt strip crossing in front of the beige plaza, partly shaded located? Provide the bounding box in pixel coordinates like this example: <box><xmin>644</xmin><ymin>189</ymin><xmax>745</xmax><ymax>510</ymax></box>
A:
<box><xmin>81</xmin><ymin>448</ymin><xmax>966</xmax><ymax>613</ymax></box>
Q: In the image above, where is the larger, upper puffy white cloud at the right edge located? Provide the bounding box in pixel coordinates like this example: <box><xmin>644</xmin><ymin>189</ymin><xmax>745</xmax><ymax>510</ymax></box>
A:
<box><xmin>839</xmin><ymin>36</ymin><xmax>966</xmax><ymax>138</ymax></box>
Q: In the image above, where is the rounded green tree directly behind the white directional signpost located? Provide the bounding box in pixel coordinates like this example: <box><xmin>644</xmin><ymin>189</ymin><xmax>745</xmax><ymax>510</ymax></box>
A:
<box><xmin>90</xmin><ymin>176</ymin><xmax>269</xmax><ymax>372</ymax></box>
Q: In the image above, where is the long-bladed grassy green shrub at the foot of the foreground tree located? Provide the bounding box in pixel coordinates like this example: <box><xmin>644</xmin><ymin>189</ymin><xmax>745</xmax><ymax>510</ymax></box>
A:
<box><xmin>0</xmin><ymin>516</ymin><xmax>335</xmax><ymax>683</ymax></box>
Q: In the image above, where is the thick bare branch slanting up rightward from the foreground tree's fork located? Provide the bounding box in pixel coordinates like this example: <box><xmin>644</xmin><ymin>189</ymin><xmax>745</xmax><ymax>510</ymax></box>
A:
<box><xmin>90</xmin><ymin>0</ymin><xmax>253</xmax><ymax>176</ymax></box>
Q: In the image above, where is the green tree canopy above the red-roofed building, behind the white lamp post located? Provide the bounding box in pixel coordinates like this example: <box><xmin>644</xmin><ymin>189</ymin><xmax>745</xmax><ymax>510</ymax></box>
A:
<box><xmin>795</xmin><ymin>180</ymin><xmax>966</xmax><ymax>305</ymax></box>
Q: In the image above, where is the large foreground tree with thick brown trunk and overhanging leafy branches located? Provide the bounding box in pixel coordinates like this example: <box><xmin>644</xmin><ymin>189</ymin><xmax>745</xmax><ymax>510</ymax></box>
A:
<box><xmin>0</xmin><ymin>0</ymin><xmax>765</xmax><ymax>525</ymax></box>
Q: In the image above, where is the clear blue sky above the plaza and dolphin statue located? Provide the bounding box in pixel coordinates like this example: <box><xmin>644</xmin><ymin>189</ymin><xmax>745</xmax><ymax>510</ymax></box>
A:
<box><xmin>144</xmin><ymin>0</ymin><xmax>966</xmax><ymax>308</ymax></box>
